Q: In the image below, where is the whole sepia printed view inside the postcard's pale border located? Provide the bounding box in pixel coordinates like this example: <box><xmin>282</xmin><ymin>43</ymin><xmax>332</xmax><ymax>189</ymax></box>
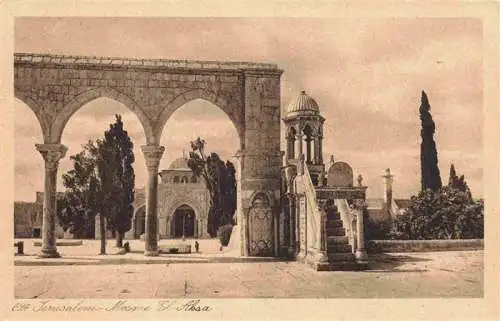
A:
<box><xmin>1</xmin><ymin>1</ymin><xmax>498</xmax><ymax>313</ymax></box>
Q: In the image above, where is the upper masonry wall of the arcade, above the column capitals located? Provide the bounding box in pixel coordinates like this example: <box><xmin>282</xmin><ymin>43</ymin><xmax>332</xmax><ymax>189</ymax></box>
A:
<box><xmin>14</xmin><ymin>54</ymin><xmax>281</xmax><ymax>143</ymax></box>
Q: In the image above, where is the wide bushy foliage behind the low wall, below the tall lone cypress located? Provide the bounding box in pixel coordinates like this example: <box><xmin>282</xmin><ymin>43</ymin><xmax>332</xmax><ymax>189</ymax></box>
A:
<box><xmin>391</xmin><ymin>186</ymin><xmax>484</xmax><ymax>240</ymax></box>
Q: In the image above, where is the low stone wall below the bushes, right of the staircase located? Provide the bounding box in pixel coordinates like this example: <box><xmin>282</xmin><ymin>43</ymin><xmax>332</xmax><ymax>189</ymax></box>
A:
<box><xmin>368</xmin><ymin>239</ymin><xmax>484</xmax><ymax>253</ymax></box>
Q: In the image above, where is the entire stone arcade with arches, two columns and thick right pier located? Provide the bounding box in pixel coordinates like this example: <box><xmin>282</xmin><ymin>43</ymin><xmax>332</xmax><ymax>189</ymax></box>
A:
<box><xmin>14</xmin><ymin>53</ymin><xmax>283</xmax><ymax>257</ymax></box>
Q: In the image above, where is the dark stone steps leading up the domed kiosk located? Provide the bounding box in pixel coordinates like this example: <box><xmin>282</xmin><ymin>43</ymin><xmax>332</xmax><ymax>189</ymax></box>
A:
<box><xmin>317</xmin><ymin>205</ymin><xmax>368</xmax><ymax>271</ymax></box>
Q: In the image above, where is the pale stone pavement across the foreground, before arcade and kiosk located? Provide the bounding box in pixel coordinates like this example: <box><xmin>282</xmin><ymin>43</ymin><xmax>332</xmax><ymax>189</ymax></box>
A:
<box><xmin>14</xmin><ymin>251</ymin><xmax>484</xmax><ymax>299</ymax></box>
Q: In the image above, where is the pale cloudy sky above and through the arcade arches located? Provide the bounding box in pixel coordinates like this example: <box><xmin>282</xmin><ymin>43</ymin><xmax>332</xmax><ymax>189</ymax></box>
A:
<box><xmin>14</xmin><ymin>17</ymin><xmax>483</xmax><ymax>201</ymax></box>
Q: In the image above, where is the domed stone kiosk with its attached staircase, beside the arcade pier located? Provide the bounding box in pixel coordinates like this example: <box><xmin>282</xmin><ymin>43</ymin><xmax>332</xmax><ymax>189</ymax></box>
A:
<box><xmin>281</xmin><ymin>91</ymin><xmax>367</xmax><ymax>270</ymax></box>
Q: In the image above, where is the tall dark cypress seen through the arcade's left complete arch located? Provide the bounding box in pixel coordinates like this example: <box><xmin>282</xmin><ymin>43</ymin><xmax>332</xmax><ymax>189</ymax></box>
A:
<box><xmin>99</xmin><ymin>115</ymin><xmax>135</xmax><ymax>247</ymax></box>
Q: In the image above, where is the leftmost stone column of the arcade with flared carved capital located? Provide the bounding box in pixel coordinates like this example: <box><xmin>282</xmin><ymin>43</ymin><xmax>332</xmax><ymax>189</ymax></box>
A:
<box><xmin>35</xmin><ymin>144</ymin><xmax>68</xmax><ymax>258</ymax></box>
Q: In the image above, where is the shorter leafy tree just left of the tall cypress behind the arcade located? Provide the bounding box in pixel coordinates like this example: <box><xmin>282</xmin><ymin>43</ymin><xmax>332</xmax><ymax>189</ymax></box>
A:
<box><xmin>57</xmin><ymin>141</ymin><xmax>101</xmax><ymax>238</ymax></box>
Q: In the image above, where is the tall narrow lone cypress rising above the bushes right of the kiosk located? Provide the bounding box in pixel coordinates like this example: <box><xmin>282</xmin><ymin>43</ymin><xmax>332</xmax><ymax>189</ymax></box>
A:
<box><xmin>420</xmin><ymin>90</ymin><xmax>442</xmax><ymax>191</ymax></box>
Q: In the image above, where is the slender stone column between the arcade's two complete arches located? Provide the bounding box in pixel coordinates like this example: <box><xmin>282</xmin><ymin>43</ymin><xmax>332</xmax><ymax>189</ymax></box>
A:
<box><xmin>142</xmin><ymin>145</ymin><xmax>165</xmax><ymax>256</ymax></box>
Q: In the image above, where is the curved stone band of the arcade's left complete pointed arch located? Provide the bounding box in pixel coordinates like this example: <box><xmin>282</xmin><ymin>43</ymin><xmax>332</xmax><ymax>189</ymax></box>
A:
<box><xmin>51</xmin><ymin>87</ymin><xmax>157</xmax><ymax>144</ymax></box>
